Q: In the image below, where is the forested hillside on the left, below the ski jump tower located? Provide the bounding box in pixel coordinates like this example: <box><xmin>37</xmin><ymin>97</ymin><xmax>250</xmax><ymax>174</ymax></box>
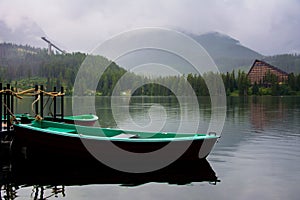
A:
<box><xmin>0</xmin><ymin>43</ymin><xmax>126</xmax><ymax>95</ymax></box>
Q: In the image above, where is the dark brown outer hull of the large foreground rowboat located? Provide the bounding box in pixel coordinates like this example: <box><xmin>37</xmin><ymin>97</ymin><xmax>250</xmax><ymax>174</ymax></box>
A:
<box><xmin>13</xmin><ymin>126</ymin><xmax>217</xmax><ymax>162</ymax></box>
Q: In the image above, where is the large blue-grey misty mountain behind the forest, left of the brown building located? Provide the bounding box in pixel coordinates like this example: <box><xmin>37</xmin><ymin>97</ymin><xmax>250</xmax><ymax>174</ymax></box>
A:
<box><xmin>117</xmin><ymin>32</ymin><xmax>263</xmax><ymax>75</ymax></box>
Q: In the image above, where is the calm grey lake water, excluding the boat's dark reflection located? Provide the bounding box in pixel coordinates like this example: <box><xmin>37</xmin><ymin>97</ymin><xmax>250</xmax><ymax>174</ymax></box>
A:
<box><xmin>1</xmin><ymin>97</ymin><xmax>300</xmax><ymax>200</ymax></box>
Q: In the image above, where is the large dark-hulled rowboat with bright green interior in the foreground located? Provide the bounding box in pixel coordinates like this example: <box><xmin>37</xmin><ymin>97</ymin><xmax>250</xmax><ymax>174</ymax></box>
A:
<box><xmin>14</xmin><ymin>120</ymin><xmax>219</xmax><ymax>160</ymax></box>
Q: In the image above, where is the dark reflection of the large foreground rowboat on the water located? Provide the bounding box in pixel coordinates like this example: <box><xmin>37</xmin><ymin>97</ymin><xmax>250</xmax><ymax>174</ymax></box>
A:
<box><xmin>0</xmin><ymin>156</ymin><xmax>219</xmax><ymax>199</ymax></box>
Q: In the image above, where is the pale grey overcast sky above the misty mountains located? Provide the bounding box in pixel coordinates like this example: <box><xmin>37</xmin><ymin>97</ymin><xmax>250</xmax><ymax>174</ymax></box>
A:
<box><xmin>0</xmin><ymin>0</ymin><xmax>300</xmax><ymax>55</ymax></box>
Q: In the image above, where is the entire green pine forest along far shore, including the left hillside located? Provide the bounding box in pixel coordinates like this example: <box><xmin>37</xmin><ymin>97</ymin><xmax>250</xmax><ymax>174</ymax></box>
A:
<box><xmin>0</xmin><ymin>43</ymin><xmax>300</xmax><ymax>96</ymax></box>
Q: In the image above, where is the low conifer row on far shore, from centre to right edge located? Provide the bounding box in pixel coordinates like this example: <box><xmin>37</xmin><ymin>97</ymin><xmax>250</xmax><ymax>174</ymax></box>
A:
<box><xmin>130</xmin><ymin>70</ymin><xmax>300</xmax><ymax>96</ymax></box>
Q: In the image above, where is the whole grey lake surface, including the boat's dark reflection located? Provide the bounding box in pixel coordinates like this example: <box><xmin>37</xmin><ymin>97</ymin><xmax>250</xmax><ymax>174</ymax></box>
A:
<box><xmin>0</xmin><ymin>97</ymin><xmax>300</xmax><ymax>200</ymax></box>
